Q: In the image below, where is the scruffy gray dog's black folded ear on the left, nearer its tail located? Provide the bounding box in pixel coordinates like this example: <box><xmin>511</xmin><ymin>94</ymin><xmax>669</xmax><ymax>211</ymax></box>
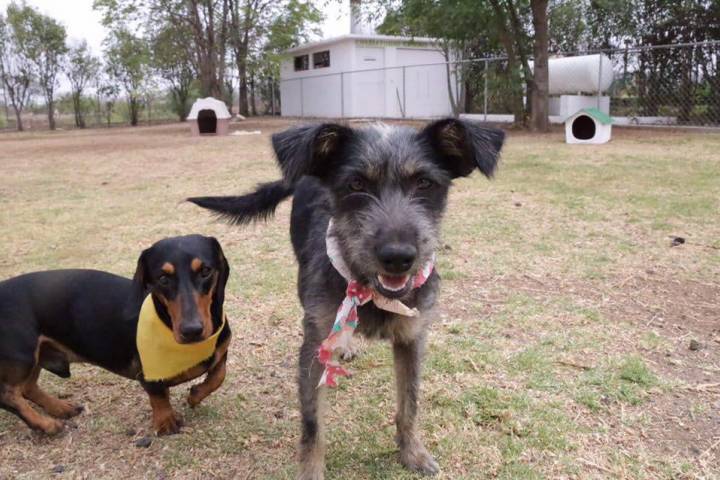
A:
<box><xmin>272</xmin><ymin>123</ymin><xmax>353</xmax><ymax>185</ymax></box>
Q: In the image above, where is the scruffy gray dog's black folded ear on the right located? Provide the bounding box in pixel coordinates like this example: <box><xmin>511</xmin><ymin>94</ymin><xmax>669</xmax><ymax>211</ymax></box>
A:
<box><xmin>420</xmin><ymin>118</ymin><xmax>505</xmax><ymax>178</ymax></box>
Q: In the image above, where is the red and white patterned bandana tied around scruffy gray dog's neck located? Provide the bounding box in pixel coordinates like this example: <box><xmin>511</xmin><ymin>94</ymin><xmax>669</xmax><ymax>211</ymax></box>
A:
<box><xmin>318</xmin><ymin>219</ymin><xmax>435</xmax><ymax>387</ymax></box>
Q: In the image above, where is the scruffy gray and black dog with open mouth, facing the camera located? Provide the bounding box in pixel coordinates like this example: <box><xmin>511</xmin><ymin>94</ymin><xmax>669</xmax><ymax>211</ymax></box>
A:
<box><xmin>189</xmin><ymin>119</ymin><xmax>504</xmax><ymax>479</ymax></box>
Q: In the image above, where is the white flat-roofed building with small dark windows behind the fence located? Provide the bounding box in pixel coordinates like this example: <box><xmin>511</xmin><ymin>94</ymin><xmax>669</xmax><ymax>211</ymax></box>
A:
<box><xmin>280</xmin><ymin>34</ymin><xmax>457</xmax><ymax>118</ymax></box>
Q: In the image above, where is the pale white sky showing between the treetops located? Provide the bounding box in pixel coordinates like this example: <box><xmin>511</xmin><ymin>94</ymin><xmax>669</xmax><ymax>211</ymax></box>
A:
<box><xmin>0</xmin><ymin>0</ymin><xmax>350</xmax><ymax>55</ymax></box>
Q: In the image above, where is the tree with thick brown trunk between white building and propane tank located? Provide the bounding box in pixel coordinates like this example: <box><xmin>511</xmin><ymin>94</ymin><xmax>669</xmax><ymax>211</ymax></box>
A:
<box><xmin>376</xmin><ymin>0</ymin><xmax>549</xmax><ymax>131</ymax></box>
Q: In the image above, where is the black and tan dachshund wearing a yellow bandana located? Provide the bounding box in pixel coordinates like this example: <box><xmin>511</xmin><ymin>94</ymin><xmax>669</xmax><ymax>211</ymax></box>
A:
<box><xmin>0</xmin><ymin>235</ymin><xmax>231</xmax><ymax>435</ymax></box>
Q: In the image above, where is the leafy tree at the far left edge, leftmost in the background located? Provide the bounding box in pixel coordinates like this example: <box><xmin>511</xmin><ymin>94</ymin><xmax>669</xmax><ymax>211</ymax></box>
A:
<box><xmin>0</xmin><ymin>3</ymin><xmax>34</xmax><ymax>131</ymax></box>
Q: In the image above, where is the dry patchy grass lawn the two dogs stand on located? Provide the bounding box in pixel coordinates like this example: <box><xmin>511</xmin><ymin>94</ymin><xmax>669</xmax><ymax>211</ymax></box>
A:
<box><xmin>0</xmin><ymin>120</ymin><xmax>720</xmax><ymax>479</ymax></box>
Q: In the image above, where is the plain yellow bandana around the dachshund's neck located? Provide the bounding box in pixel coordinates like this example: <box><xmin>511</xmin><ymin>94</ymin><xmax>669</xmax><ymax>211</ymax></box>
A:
<box><xmin>135</xmin><ymin>295</ymin><xmax>225</xmax><ymax>382</ymax></box>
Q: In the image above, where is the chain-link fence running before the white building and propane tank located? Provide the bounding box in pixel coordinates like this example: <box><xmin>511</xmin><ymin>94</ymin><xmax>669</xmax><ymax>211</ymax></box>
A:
<box><xmin>280</xmin><ymin>41</ymin><xmax>720</xmax><ymax>126</ymax></box>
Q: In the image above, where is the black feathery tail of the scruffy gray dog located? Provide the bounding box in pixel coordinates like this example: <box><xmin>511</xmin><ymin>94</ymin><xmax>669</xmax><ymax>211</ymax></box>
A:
<box><xmin>187</xmin><ymin>180</ymin><xmax>294</xmax><ymax>225</ymax></box>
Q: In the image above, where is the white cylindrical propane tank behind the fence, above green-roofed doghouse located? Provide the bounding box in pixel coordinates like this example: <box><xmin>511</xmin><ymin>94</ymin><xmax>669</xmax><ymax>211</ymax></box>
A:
<box><xmin>548</xmin><ymin>54</ymin><xmax>613</xmax><ymax>95</ymax></box>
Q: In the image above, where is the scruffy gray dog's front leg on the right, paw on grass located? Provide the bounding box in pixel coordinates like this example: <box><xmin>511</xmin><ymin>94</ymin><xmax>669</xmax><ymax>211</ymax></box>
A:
<box><xmin>393</xmin><ymin>338</ymin><xmax>440</xmax><ymax>475</ymax></box>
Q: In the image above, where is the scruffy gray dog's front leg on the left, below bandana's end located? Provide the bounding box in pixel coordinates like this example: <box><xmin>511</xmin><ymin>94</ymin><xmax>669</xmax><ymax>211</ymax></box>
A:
<box><xmin>298</xmin><ymin>320</ymin><xmax>325</xmax><ymax>480</ymax></box>
